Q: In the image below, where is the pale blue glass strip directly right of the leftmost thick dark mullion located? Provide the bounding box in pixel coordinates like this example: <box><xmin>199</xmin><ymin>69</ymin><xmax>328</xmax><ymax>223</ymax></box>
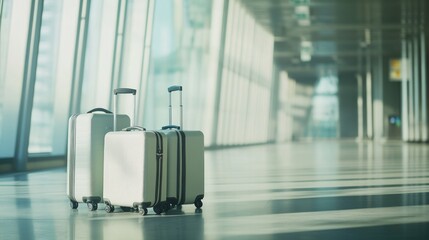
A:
<box><xmin>28</xmin><ymin>0</ymin><xmax>66</xmax><ymax>153</ymax></box>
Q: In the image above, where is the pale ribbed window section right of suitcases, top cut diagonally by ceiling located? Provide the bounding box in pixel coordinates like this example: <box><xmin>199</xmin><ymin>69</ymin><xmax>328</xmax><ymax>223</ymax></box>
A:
<box><xmin>216</xmin><ymin>1</ymin><xmax>274</xmax><ymax>145</ymax></box>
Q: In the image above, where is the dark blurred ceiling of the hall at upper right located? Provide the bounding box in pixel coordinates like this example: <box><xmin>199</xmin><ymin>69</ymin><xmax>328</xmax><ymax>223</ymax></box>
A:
<box><xmin>241</xmin><ymin>0</ymin><xmax>429</xmax><ymax>81</ymax></box>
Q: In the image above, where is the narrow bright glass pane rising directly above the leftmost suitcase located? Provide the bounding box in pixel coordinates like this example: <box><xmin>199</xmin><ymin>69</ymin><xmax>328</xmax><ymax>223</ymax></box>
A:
<box><xmin>80</xmin><ymin>0</ymin><xmax>118</xmax><ymax>112</ymax></box>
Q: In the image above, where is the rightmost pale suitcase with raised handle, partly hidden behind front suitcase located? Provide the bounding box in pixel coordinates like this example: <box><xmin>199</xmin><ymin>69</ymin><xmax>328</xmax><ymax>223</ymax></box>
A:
<box><xmin>162</xmin><ymin>86</ymin><xmax>204</xmax><ymax>209</ymax></box>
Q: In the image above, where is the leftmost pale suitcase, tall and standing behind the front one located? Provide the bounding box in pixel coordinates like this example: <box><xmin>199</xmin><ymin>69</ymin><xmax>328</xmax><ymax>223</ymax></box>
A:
<box><xmin>67</xmin><ymin>108</ymin><xmax>130</xmax><ymax>211</ymax></box>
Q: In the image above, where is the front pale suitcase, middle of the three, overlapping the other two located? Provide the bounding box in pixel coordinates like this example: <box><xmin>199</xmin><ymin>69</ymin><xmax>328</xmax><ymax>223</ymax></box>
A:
<box><xmin>104</xmin><ymin>89</ymin><xmax>168</xmax><ymax>215</ymax></box>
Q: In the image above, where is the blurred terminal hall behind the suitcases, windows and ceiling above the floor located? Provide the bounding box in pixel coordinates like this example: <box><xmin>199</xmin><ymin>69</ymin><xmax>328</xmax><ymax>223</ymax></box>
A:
<box><xmin>0</xmin><ymin>0</ymin><xmax>429</xmax><ymax>172</ymax></box>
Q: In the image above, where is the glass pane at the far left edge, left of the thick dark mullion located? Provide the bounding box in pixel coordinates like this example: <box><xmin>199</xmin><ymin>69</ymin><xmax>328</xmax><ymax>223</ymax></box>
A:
<box><xmin>0</xmin><ymin>0</ymin><xmax>31</xmax><ymax>158</ymax></box>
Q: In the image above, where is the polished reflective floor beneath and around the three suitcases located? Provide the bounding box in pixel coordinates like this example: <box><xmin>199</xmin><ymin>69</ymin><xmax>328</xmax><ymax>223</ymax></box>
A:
<box><xmin>0</xmin><ymin>141</ymin><xmax>429</xmax><ymax>240</ymax></box>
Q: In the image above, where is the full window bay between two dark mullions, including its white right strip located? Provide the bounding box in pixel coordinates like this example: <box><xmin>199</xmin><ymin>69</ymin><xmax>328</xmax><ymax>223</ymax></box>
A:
<box><xmin>28</xmin><ymin>0</ymin><xmax>79</xmax><ymax>155</ymax></box>
